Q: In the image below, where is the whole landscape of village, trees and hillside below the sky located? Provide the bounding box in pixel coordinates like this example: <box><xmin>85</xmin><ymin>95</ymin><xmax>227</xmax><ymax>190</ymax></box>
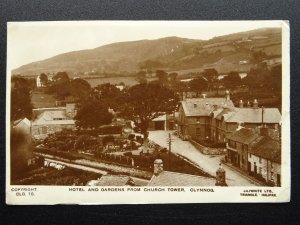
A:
<box><xmin>10</xmin><ymin>25</ymin><xmax>283</xmax><ymax>187</ymax></box>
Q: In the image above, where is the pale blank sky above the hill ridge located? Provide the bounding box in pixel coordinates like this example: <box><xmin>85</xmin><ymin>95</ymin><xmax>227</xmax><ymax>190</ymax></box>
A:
<box><xmin>7</xmin><ymin>21</ymin><xmax>283</xmax><ymax>71</ymax></box>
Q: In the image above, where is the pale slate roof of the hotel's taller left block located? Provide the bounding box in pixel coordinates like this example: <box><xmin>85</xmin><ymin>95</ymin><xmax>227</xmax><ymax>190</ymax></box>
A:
<box><xmin>181</xmin><ymin>98</ymin><xmax>234</xmax><ymax>116</ymax></box>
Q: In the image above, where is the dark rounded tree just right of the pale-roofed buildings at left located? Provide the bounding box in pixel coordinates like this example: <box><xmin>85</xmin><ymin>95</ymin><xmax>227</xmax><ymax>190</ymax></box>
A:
<box><xmin>74</xmin><ymin>98</ymin><xmax>113</xmax><ymax>129</ymax></box>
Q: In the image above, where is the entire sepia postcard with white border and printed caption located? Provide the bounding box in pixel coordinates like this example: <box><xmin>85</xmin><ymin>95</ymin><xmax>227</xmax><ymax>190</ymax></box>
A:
<box><xmin>6</xmin><ymin>21</ymin><xmax>290</xmax><ymax>204</ymax></box>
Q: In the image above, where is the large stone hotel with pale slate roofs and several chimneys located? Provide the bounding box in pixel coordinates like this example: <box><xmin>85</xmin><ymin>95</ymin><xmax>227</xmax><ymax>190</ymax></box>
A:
<box><xmin>178</xmin><ymin>91</ymin><xmax>281</xmax><ymax>143</ymax></box>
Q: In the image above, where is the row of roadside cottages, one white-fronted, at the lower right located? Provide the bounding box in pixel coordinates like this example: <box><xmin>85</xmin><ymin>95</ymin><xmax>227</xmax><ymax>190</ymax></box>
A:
<box><xmin>226</xmin><ymin>126</ymin><xmax>281</xmax><ymax>186</ymax></box>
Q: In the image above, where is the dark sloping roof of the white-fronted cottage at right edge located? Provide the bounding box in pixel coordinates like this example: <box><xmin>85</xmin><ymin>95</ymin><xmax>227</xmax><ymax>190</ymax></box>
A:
<box><xmin>249</xmin><ymin>136</ymin><xmax>281</xmax><ymax>164</ymax></box>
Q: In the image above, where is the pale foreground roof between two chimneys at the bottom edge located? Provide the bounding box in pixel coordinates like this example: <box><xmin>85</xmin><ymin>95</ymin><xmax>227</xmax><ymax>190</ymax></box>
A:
<box><xmin>148</xmin><ymin>171</ymin><xmax>216</xmax><ymax>186</ymax></box>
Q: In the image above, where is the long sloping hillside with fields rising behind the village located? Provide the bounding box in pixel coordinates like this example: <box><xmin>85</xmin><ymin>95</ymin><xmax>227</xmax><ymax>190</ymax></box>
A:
<box><xmin>12</xmin><ymin>28</ymin><xmax>281</xmax><ymax>76</ymax></box>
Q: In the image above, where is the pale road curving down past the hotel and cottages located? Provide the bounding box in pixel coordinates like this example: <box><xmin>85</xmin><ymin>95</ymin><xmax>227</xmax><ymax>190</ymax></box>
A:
<box><xmin>149</xmin><ymin>131</ymin><xmax>257</xmax><ymax>186</ymax></box>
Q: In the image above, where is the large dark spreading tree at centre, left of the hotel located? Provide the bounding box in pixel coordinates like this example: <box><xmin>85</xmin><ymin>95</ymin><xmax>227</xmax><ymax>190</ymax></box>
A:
<box><xmin>121</xmin><ymin>83</ymin><xmax>178</xmax><ymax>135</ymax></box>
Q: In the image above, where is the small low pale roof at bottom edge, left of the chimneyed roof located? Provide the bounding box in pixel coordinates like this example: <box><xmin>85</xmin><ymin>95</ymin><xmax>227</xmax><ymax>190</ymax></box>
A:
<box><xmin>87</xmin><ymin>174</ymin><xmax>132</xmax><ymax>186</ymax></box>
